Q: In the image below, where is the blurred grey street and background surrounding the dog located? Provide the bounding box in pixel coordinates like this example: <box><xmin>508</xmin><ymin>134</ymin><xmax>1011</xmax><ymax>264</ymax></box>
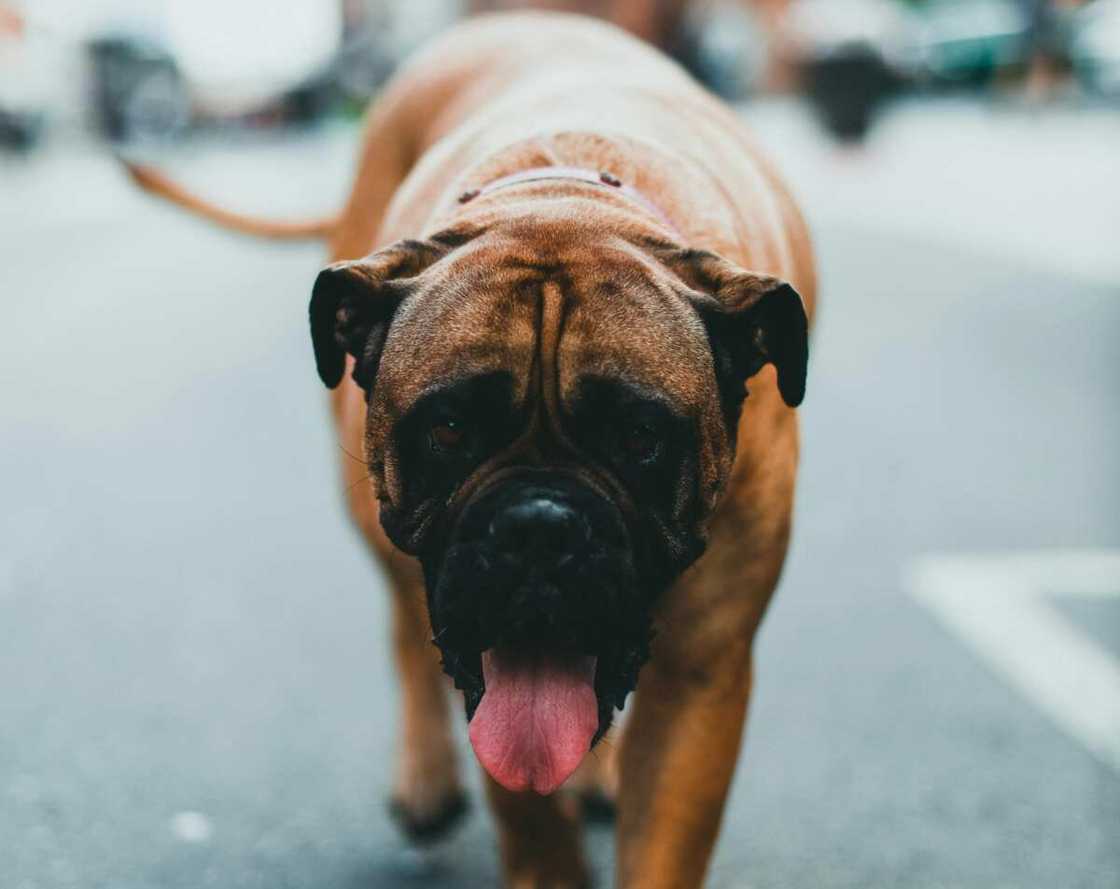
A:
<box><xmin>0</xmin><ymin>0</ymin><xmax>1120</xmax><ymax>889</ymax></box>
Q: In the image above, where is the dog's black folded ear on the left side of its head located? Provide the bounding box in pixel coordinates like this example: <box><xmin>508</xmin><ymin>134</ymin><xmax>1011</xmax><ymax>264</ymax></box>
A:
<box><xmin>310</xmin><ymin>241</ymin><xmax>447</xmax><ymax>394</ymax></box>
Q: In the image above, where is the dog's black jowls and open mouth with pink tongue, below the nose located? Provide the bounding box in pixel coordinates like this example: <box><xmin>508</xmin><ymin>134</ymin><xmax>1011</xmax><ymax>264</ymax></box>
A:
<box><xmin>429</xmin><ymin>546</ymin><xmax>653</xmax><ymax>795</ymax></box>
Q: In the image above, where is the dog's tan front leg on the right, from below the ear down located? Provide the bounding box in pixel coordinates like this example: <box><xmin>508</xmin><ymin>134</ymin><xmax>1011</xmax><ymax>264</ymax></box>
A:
<box><xmin>617</xmin><ymin>405</ymin><xmax>797</xmax><ymax>889</ymax></box>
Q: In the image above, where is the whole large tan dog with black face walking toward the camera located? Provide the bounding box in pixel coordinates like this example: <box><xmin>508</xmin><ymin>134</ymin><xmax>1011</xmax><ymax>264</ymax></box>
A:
<box><xmin>128</xmin><ymin>15</ymin><xmax>815</xmax><ymax>889</ymax></box>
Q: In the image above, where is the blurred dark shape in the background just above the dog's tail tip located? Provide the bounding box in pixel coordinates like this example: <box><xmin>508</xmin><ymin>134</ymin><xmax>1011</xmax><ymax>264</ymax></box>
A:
<box><xmin>87</xmin><ymin>34</ymin><xmax>192</xmax><ymax>142</ymax></box>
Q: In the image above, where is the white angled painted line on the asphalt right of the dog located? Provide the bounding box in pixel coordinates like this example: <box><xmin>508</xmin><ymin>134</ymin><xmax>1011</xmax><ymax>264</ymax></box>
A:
<box><xmin>906</xmin><ymin>550</ymin><xmax>1120</xmax><ymax>771</ymax></box>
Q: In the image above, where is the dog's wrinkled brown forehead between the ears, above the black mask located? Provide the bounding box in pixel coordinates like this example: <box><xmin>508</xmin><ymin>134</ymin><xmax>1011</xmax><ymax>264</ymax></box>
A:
<box><xmin>377</xmin><ymin>235</ymin><xmax>711</xmax><ymax>415</ymax></box>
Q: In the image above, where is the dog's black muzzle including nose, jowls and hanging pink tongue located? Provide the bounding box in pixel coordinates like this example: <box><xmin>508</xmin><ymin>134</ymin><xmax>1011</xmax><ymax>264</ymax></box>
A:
<box><xmin>421</xmin><ymin>476</ymin><xmax>660</xmax><ymax>795</ymax></box>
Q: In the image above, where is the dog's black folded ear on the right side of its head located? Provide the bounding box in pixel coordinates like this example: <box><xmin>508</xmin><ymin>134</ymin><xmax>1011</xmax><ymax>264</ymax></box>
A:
<box><xmin>659</xmin><ymin>250</ymin><xmax>809</xmax><ymax>417</ymax></box>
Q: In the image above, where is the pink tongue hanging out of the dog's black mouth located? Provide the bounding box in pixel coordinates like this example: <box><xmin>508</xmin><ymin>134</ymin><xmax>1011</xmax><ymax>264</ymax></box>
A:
<box><xmin>470</xmin><ymin>648</ymin><xmax>599</xmax><ymax>794</ymax></box>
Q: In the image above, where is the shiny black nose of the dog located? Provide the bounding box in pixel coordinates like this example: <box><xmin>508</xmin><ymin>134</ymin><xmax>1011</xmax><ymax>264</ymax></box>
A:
<box><xmin>489</xmin><ymin>496</ymin><xmax>587</xmax><ymax>565</ymax></box>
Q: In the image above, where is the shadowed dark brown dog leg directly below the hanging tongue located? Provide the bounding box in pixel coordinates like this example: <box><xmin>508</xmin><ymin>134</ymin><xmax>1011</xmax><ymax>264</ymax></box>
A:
<box><xmin>486</xmin><ymin>775</ymin><xmax>590</xmax><ymax>889</ymax></box>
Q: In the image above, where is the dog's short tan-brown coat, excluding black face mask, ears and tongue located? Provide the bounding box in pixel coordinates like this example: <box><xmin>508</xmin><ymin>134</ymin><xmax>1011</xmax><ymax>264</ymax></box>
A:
<box><xmin>128</xmin><ymin>13</ymin><xmax>816</xmax><ymax>889</ymax></box>
